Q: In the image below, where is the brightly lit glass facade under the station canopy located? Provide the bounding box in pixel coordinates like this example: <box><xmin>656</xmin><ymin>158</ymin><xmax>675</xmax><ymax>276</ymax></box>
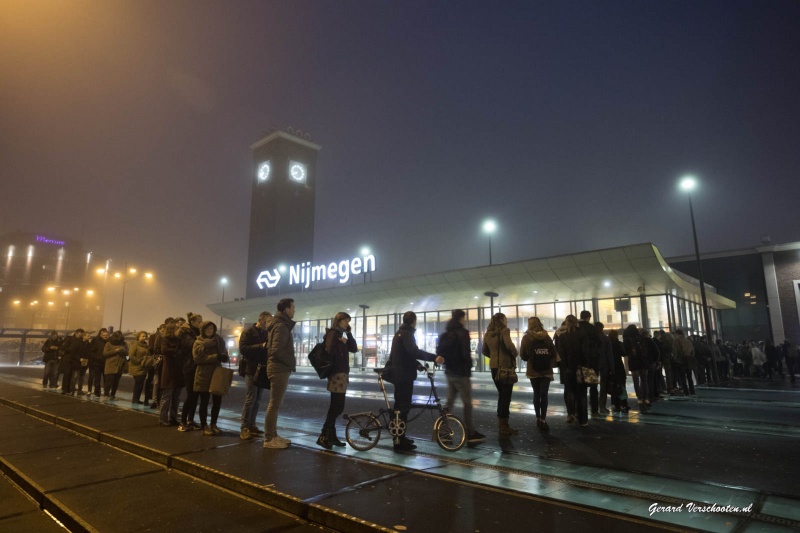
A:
<box><xmin>286</xmin><ymin>294</ymin><xmax>718</xmax><ymax>372</ymax></box>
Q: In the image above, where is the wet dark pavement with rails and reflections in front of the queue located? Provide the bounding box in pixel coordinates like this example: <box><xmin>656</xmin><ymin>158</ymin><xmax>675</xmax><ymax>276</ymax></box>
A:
<box><xmin>0</xmin><ymin>369</ymin><xmax>800</xmax><ymax>532</ymax></box>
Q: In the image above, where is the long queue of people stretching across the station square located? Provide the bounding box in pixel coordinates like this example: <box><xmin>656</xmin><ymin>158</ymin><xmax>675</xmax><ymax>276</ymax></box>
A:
<box><xmin>42</xmin><ymin>298</ymin><xmax>798</xmax><ymax>452</ymax></box>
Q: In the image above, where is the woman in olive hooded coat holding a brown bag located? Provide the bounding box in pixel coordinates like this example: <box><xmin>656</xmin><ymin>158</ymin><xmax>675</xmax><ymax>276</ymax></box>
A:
<box><xmin>193</xmin><ymin>318</ymin><xmax>228</xmax><ymax>435</ymax></box>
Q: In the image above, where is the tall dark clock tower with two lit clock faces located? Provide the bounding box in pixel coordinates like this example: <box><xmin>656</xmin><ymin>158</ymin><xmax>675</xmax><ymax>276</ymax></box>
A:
<box><xmin>246</xmin><ymin>128</ymin><xmax>320</xmax><ymax>298</ymax></box>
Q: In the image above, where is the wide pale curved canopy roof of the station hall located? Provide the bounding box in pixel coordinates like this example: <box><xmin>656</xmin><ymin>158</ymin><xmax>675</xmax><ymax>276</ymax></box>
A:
<box><xmin>208</xmin><ymin>243</ymin><xmax>736</xmax><ymax>323</ymax></box>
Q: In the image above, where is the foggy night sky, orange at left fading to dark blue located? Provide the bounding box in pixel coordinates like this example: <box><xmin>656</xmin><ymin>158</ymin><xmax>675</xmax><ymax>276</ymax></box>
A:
<box><xmin>0</xmin><ymin>0</ymin><xmax>800</xmax><ymax>330</ymax></box>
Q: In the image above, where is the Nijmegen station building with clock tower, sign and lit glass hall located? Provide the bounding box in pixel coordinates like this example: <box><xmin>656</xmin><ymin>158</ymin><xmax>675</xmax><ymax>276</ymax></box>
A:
<box><xmin>208</xmin><ymin>128</ymin><xmax>800</xmax><ymax>370</ymax></box>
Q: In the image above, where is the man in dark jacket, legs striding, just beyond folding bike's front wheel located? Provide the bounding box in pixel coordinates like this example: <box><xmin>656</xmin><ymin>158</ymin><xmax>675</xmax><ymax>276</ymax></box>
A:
<box><xmin>436</xmin><ymin>309</ymin><xmax>486</xmax><ymax>442</ymax></box>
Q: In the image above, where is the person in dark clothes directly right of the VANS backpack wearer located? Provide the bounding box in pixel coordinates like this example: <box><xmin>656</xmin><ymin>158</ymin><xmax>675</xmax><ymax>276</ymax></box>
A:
<box><xmin>555</xmin><ymin>315</ymin><xmax>589</xmax><ymax>427</ymax></box>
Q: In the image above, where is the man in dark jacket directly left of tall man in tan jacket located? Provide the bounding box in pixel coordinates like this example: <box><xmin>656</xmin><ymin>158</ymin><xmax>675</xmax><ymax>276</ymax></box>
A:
<box><xmin>239</xmin><ymin>311</ymin><xmax>272</xmax><ymax>440</ymax></box>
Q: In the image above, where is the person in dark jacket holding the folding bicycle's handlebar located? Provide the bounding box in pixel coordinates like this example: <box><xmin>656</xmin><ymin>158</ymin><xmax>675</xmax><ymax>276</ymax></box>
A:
<box><xmin>386</xmin><ymin>311</ymin><xmax>444</xmax><ymax>452</ymax></box>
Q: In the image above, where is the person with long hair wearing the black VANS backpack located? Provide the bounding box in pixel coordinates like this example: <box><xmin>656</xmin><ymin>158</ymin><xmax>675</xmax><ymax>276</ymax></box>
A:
<box><xmin>519</xmin><ymin>316</ymin><xmax>558</xmax><ymax>431</ymax></box>
